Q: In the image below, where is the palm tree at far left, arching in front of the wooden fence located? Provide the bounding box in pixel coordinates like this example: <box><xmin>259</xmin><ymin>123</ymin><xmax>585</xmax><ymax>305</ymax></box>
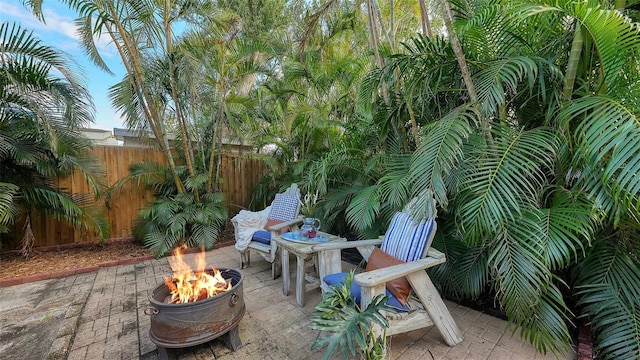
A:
<box><xmin>0</xmin><ymin>23</ymin><xmax>105</xmax><ymax>256</ymax></box>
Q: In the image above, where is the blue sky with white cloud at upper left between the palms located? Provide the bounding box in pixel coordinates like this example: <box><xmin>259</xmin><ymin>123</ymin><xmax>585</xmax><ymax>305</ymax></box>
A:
<box><xmin>0</xmin><ymin>0</ymin><xmax>125</xmax><ymax>131</ymax></box>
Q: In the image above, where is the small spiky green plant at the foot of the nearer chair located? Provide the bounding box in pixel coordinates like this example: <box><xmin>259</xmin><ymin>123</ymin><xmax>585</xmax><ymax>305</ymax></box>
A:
<box><xmin>309</xmin><ymin>270</ymin><xmax>393</xmax><ymax>360</ymax></box>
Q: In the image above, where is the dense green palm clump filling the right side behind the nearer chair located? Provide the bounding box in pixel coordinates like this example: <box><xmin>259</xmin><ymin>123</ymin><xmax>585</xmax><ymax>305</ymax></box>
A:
<box><xmin>342</xmin><ymin>1</ymin><xmax>640</xmax><ymax>358</ymax></box>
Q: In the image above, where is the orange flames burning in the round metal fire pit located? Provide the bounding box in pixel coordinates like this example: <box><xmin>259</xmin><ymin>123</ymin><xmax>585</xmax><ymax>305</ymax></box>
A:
<box><xmin>164</xmin><ymin>248</ymin><xmax>232</xmax><ymax>304</ymax></box>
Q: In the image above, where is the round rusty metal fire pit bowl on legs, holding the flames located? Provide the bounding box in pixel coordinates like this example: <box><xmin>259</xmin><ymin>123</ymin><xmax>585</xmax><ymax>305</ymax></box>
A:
<box><xmin>145</xmin><ymin>267</ymin><xmax>245</xmax><ymax>359</ymax></box>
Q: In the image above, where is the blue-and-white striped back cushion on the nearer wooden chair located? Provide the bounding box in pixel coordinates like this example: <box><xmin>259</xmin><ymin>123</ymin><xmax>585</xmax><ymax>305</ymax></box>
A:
<box><xmin>380</xmin><ymin>212</ymin><xmax>435</xmax><ymax>262</ymax></box>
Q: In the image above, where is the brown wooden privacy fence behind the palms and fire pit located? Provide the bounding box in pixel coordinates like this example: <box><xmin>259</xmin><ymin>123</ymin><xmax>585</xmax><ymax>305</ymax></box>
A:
<box><xmin>6</xmin><ymin>146</ymin><xmax>266</xmax><ymax>246</ymax></box>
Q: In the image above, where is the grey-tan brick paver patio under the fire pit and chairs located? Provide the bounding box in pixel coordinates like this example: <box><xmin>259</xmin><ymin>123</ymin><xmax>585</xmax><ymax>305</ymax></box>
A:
<box><xmin>0</xmin><ymin>246</ymin><xmax>576</xmax><ymax>360</ymax></box>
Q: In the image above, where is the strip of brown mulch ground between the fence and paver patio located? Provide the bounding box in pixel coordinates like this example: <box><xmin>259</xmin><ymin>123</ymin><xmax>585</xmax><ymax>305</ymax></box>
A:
<box><xmin>0</xmin><ymin>223</ymin><xmax>234</xmax><ymax>279</ymax></box>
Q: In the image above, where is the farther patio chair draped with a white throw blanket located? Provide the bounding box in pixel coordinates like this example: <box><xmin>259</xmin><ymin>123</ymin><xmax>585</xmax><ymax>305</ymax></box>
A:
<box><xmin>231</xmin><ymin>183</ymin><xmax>302</xmax><ymax>279</ymax></box>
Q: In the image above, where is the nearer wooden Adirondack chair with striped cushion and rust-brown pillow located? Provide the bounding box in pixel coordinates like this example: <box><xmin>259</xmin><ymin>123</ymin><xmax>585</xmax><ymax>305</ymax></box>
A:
<box><xmin>314</xmin><ymin>210</ymin><xmax>462</xmax><ymax>347</ymax></box>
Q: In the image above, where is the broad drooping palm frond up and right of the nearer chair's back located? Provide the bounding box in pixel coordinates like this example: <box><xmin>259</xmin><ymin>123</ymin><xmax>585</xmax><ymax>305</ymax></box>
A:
<box><xmin>456</xmin><ymin>126</ymin><xmax>557</xmax><ymax>242</ymax></box>
